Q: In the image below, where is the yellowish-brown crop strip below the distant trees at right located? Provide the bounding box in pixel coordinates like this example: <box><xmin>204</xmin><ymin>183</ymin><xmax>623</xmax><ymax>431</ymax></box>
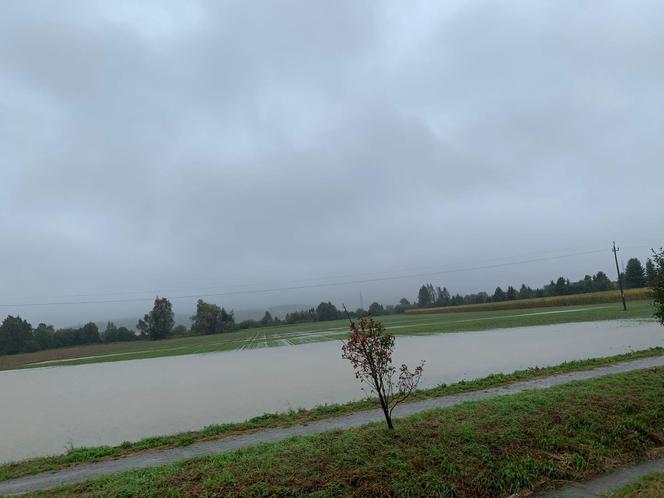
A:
<box><xmin>406</xmin><ymin>288</ymin><xmax>651</xmax><ymax>315</ymax></box>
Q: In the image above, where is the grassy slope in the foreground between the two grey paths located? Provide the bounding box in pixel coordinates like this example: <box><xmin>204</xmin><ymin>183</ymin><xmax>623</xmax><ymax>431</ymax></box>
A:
<box><xmin>26</xmin><ymin>368</ymin><xmax>664</xmax><ymax>498</ymax></box>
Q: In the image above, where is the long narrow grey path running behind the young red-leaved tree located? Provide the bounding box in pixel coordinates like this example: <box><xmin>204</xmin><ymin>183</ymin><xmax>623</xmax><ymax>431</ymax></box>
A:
<box><xmin>5</xmin><ymin>356</ymin><xmax>664</xmax><ymax>495</ymax></box>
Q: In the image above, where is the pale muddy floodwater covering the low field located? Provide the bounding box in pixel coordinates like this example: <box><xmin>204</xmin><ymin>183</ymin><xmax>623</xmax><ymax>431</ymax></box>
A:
<box><xmin>0</xmin><ymin>320</ymin><xmax>664</xmax><ymax>462</ymax></box>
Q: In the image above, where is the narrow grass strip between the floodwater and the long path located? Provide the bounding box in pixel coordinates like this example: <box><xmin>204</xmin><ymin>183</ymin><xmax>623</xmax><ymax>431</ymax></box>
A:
<box><xmin>0</xmin><ymin>348</ymin><xmax>664</xmax><ymax>481</ymax></box>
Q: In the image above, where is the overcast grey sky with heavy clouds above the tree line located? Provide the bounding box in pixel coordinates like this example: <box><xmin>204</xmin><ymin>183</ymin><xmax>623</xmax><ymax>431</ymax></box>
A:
<box><xmin>0</xmin><ymin>0</ymin><xmax>664</xmax><ymax>324</ymax></box>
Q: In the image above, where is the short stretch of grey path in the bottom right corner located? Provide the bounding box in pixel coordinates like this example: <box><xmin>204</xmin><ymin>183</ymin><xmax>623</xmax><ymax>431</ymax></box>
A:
<box><xmin>536</xmin><ymin>458</ymin><xmax>664</xmax><ymax>498</ymax></box>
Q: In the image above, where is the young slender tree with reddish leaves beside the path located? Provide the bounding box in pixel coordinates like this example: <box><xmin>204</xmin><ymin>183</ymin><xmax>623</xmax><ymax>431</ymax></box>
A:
<box><xmin>341</xmin><ymin>318</ymin><xmax>424</xmax><ymax>430</ymax></box>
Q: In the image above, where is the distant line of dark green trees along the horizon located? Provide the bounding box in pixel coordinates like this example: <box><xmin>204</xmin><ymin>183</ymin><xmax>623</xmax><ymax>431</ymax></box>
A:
<box><xmin>0</xmin><ymin>253</ymin><xmax>664</xmax><ymax>354</ymax></box>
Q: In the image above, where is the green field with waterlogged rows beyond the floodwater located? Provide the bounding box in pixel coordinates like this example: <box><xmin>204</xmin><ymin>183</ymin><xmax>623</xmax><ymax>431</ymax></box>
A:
<box><xmin>0</xmin><ymin>301</ymin><xmax>653</xmax><ymax>370</ymax></box>
